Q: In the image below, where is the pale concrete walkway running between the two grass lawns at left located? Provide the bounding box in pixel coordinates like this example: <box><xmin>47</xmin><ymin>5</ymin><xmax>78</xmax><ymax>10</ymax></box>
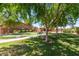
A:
<box><xmin>0</xmin><ymin>34</ymin><xmax>45</xmax><ymax>43</ymax></box>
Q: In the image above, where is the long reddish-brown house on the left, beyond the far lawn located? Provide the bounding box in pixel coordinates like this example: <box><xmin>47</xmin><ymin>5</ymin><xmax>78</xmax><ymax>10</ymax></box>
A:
<box><xmin>0</xmin><ymin>23</ymin><xmax>32</xmax><ymax>35</ymax></box>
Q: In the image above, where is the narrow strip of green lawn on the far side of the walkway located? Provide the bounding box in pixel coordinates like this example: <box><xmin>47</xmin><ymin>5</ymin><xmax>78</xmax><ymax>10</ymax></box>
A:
<box><xmin>0</xmin><ymin>32</ymin><xmax>37</xmax><ymax>39</ymax></box>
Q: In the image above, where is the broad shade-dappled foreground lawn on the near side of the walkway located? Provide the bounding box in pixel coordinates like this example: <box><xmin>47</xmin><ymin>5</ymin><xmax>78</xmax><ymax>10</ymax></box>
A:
<box><xmin>0</xmin><ymin>34</ymin><xmax>79</xmax><ymax>56</ymax></box>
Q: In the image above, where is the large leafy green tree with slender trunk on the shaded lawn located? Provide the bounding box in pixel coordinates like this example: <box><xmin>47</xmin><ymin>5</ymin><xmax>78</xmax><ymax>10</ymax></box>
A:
<box><xmin>33</xmin><ymin>3</ymin><xmax>79</xmax><ymax>41</ymax></box>
